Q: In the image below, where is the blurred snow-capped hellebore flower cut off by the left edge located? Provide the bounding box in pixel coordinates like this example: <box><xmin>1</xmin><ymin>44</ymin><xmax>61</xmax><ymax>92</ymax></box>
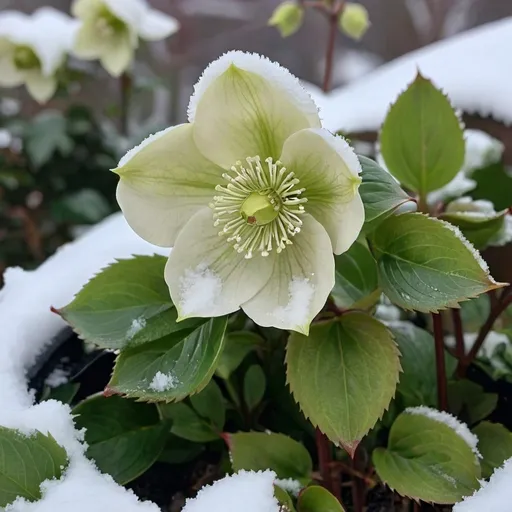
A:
<box><xmin>0</xmin><ymin>7</ymin><xmax>77</xmax><ymax>103</ymax></box>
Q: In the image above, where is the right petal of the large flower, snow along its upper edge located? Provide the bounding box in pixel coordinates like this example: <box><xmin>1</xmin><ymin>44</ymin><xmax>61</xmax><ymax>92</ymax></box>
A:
<box><xmin>280</xmin><ymin>128</ymin><xmax>364</xmax><ymax>254</ymax></box>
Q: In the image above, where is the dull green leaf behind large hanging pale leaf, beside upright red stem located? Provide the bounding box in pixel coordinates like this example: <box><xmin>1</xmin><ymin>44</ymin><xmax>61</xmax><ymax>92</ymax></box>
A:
<box><xmin>391</xmin><ymin>322</ymin><xmax>457</xmax><ymax>407</ymax></box>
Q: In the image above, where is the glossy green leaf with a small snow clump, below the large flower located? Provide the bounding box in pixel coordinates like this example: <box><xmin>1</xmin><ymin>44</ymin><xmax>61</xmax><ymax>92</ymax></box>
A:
<box><xmin>107</xmin><ymin>317</ymin><xmax>227</xmax><ymax>402</ymax></box>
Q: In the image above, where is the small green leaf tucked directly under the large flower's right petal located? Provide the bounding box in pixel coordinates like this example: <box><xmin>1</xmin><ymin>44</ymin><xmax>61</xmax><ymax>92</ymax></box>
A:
<box><xmin>332</xmin><ymin>242</ymin><xmax>380</xmax><ymax>309</ymax></box>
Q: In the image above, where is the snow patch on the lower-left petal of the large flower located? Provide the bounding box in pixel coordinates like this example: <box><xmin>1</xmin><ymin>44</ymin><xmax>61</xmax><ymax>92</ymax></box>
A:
<box><xmin>180</xmin><ymin>263</ymin><xmax>222</xmax><ymax>316</ymax></box>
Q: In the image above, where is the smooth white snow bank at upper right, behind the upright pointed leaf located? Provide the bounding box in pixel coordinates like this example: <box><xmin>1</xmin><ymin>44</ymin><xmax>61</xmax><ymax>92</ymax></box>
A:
<box><xmin>310</xmin><ymin>17</ymin><xmax>512</xmax><ymax>133</ymax></box>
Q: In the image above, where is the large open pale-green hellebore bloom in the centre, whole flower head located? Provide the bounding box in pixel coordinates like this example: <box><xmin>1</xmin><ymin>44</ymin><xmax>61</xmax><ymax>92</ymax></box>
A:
<box><xmin>115</xmin><ymin>52</ymin><xmax>364</xmax><ymax>334</ymax></box>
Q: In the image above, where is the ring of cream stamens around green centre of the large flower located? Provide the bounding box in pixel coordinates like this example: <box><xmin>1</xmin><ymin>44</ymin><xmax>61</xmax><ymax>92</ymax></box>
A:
<box><xmin>210</xmin><ymin>156</ymin><xmax>307</xmax><ymax>259</ymax></box>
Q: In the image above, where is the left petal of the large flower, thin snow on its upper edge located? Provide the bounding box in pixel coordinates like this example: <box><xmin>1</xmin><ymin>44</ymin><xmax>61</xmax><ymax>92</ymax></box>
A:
<box><xmin>116</xmin><ymin>124</ymin><xmax>222</xmax><ymax>246</ymax></box>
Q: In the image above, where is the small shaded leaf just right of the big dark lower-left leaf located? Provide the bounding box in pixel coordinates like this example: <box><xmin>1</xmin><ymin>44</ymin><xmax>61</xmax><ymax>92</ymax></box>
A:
<box><xmin>158</xmin><ymin>402</ymin><xmax>218</xmax><ymax>443</ymax></box>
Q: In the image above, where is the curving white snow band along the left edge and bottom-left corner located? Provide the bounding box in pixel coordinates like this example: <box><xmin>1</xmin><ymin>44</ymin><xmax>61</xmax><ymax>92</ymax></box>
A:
<box><xmin>0</xmin><ymin>214</ymin><xmax>168</xmax><ymax>512</ymax></box>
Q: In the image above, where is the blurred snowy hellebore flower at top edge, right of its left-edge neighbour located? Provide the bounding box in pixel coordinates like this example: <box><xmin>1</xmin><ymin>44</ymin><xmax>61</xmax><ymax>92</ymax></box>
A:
<box><xmin>72</xmin><ymin>0</ymin><xmax>179</xmax><ymax>76</ymax></box>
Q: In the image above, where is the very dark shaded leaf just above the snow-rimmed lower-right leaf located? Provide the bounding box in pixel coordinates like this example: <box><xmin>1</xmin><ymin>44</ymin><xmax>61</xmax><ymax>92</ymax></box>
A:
<box><xmin>448</xmin><ymin>380</ymin><xmax>498</xmax><ymax>426</ymax></box>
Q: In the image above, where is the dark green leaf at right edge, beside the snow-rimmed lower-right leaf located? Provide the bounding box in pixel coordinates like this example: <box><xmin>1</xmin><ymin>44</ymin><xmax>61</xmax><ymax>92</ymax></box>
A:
<box><xmin>473</xmin><ymin>421</ymin><xmax>512</xmax><ymax>478</ymax></box>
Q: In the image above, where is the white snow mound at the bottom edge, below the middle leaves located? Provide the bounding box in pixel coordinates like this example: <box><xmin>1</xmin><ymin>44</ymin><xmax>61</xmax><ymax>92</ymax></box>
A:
<box><xmin>182</xmin><ymin>470</ymin><xmax>280</xmax><ymax>512</ymax></box>
